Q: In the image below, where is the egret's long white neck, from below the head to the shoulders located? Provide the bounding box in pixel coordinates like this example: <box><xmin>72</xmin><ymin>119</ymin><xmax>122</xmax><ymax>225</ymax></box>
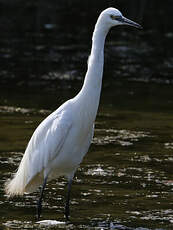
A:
<box><xmin>77</xmin><ymin>19</ymin><xmax>109</xmax><ymax>115</ymax></box>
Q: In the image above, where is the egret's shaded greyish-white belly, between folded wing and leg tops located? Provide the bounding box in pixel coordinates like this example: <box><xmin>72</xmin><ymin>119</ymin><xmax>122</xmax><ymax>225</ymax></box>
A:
<box><xmin>49</xmin><ymin>126</ymin><xmax>93</xmax><ymax>179</ymax></box>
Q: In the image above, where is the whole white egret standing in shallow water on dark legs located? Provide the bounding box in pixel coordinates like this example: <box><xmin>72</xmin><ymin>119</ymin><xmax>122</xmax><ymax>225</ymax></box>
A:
<box><xmin>5</xmin><ymin>8</ymin><xmax>141</xmax><ymax>220</ymax></box>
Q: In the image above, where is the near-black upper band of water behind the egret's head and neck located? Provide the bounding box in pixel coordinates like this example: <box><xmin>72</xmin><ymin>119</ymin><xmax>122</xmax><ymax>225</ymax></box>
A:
<box><xmin>0</xmin><ymin>0</ymin><xmax>173</xmax><ymax>87</ymax></box>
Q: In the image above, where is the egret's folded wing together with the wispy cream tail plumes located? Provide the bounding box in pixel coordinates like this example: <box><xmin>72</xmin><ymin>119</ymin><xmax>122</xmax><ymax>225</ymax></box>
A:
<box><xmin>5</xmin><ymin>109</ymin><xmax>72</xmax><ymax>196</ymax></box>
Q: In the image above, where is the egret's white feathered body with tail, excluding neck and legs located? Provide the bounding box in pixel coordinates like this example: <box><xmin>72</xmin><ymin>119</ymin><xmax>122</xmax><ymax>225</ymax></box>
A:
<box><xmin>6</xmin><ymin>100</ymin><xmax>93</xmax><ymax>195</ymax></box>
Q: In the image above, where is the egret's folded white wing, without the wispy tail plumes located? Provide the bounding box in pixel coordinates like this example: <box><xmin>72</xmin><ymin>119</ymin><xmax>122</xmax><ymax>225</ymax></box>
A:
<box><xmin>25</xmin><ymin>108</ymin><xmax>72</xmax><ymax>181</ymax></box>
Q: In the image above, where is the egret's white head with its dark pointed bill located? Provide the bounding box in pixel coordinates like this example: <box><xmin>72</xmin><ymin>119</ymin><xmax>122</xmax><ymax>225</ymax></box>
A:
<box><xmin>101</xmin><ymin>7</ymin><xmax>142</xmax><ymax>29</ymax></box>
